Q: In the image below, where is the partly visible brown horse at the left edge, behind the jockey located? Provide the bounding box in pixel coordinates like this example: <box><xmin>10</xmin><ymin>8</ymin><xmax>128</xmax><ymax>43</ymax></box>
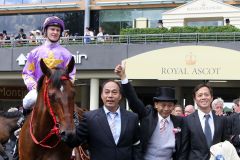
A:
<box><xmin>0</xmin><ymin>111</ymin><xmax>22</xmax><ymax>160</ymax></box>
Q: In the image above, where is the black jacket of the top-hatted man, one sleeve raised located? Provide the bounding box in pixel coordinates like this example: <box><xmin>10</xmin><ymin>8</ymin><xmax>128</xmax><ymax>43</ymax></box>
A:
<box><xmin>122</xmin><ymin>83</ymin><xmax>183</xmax><ymax>160</ymax></box>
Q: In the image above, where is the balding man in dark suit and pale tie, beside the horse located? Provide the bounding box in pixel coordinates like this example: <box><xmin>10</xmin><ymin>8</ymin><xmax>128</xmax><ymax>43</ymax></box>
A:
<box><xmin>63</xmin><ymin>80</ymin><xmax>141</xmax><ymax>160</ymax></box>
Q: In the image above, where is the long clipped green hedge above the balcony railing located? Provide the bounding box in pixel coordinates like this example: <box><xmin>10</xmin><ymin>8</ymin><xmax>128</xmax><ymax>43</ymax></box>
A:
<box><xmin>120</xmin><ymin>25</ymin><xmax>240</xmax><ymax>35</ymax></box>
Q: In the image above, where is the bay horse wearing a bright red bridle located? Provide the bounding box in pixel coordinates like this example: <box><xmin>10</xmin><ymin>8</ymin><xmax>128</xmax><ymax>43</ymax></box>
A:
<box><xmin>18</xmin><ymin>57</ymin><xmax>75</xmax><ymax>160</ymax></box>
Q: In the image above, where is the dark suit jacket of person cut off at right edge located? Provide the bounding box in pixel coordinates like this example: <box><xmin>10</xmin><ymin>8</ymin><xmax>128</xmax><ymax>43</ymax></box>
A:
<box><xmin>227</xmin><ymin>113</ymin><xmax>240</xmax><ymax>156</ymax></box>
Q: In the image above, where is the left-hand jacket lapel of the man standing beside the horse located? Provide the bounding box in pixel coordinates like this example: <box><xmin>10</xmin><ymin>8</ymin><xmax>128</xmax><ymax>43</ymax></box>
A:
<box><xmin>97</xmin><ymin>108</ymin><xmax>115</xmax><ymax>145</ymax></box>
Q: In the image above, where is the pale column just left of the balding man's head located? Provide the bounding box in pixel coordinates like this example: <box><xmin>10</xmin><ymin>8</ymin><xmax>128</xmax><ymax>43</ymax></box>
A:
<box><xmin>90</xmin><ymin>78</ymin><xmax>99</xmax><ymax>110</ymax></box>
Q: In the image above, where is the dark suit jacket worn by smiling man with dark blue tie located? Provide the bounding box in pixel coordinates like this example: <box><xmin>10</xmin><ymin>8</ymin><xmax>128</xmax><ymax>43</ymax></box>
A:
<box><xmin>180</xmin><ymin>111</ymin><xmax>227</xmax><ymax>160</ymax></box>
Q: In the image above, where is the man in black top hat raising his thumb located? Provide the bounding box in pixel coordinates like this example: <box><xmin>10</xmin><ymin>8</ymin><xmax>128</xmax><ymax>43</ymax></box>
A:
<box><xmin>115</xmin><ymin>65</ymin><xmax>183</xmax><ymax>160</ymax></box>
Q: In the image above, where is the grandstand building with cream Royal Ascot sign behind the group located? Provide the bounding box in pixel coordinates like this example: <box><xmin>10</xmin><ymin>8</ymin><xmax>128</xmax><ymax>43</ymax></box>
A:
<box><xmin>0</xmin><ymin>0</ymin><xmax>240</xmax><ymax>109</ymax></box>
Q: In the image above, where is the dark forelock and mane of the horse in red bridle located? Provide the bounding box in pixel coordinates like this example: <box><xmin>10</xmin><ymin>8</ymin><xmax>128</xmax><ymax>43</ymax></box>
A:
<box><xmin>37</xmin><ymin>68</ymin><xmax>63</xmax><ymax>92</ymax></box>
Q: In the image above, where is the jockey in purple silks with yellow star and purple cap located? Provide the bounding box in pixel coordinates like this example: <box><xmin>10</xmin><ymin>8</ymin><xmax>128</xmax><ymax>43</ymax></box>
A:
<box><xmin>13</xmin><ymin>16</ymin><xmax>76</xmax><ymax>158</ymax></box>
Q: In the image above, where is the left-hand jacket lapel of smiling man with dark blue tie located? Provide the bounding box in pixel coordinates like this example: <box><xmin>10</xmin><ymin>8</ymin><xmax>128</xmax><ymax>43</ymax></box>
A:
<box><xmin>192</xmin><ymin>111</ymin><xmax>208</xmax><ymax>147</ymax></box>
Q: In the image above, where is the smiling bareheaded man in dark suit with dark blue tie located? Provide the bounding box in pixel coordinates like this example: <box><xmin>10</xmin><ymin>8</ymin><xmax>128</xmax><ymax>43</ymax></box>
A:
<box><xmin>180</xmin><ymin>84</ymin><xmax>227</xmax><ymax>160</ymax></box>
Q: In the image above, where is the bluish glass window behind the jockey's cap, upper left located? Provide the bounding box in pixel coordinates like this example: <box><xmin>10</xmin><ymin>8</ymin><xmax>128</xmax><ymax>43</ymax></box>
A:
<box><xmin>0</xmin><ymin>11</ymin><xmax>84</xmax><ymax>37</ymax></box>
